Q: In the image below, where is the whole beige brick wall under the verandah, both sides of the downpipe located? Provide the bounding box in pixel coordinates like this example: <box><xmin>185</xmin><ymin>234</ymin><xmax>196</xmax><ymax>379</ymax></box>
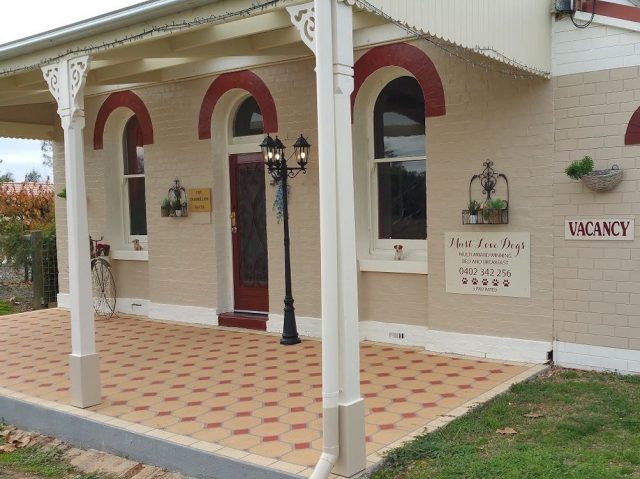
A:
<box><xmin>56</xmin><ymin>42</ymin><xmax>553</xmax><ymax>341</ymax></box>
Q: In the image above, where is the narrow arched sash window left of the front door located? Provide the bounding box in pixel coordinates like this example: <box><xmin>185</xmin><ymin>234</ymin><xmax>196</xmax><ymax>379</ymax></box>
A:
<box><xmin>122</xmin><ymin>115</ymin><xmax>147</xmax><ymax>237</ymax></box>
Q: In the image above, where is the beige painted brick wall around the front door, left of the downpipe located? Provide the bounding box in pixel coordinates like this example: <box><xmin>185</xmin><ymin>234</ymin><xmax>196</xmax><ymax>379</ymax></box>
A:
<box><xmin>55</xmin><ymin>61</ymin><xmax>320</xmax><ymax>317</ymax></box>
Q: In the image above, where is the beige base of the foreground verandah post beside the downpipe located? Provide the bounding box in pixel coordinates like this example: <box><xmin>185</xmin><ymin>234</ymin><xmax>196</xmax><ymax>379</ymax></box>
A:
<box><xmin>333</xmin><ymin>398</ymin><xmax>367</xmax><ymax>477</ymax></box>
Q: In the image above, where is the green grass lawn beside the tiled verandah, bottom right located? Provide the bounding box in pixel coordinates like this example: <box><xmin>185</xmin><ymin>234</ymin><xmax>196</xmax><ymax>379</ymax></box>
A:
<box><xmin>371</xmin><ymin>369</ymin><xmax>640</xmax><ymax>479</ymax></box>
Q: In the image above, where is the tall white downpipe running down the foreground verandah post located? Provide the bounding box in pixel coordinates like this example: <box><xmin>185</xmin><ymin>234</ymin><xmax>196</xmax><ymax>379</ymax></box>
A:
<box><xmin>311</xmin><ymin>0</ymin><xmax>340</xmax><ymax>479</ymax></box>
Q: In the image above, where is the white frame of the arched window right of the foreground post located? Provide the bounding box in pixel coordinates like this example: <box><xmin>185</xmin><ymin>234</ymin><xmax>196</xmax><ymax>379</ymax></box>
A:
<box><xmin>367</xmin><ymin>72</ymin><xmax>429</xmax><ymax>262</ymax></box>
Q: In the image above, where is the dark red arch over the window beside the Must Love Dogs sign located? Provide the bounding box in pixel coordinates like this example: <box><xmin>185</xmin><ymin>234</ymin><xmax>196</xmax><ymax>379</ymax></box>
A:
<box><xmin>351</xmin><ymin>43</ymin><xmax>446</xmax><ymax>117</ymax></box>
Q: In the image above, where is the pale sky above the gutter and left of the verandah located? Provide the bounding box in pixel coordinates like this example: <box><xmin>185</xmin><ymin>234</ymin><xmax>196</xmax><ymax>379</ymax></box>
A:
<box><xmin>0</xmin><ymin>0</ymin><xmax>142</xmax><ymax>181</ymax></box>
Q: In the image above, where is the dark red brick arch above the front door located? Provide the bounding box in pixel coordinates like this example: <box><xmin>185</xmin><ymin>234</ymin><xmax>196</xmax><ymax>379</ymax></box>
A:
<box><xmin>198</xmin><ymin>70</ymin><xmax>278</xmax><ymax>140</ymax></box>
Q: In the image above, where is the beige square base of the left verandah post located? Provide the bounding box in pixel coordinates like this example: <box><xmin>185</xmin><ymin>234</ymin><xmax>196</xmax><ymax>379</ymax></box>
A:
<box><xmin>69</xmin><ymin>354</ymin><xmax>102</xmax><ymax>408</ymax></box>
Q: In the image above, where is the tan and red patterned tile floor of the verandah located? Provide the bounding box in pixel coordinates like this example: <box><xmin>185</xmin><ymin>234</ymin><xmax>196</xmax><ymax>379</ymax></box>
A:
<box><xmin>0</xmin><ymin>309</ymin><xmax>536</xmax><ymax>476</ymax></box>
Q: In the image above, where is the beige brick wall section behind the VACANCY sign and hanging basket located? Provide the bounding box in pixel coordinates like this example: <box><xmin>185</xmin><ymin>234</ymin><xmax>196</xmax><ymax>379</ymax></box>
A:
<box><xmin>553</xmin><ymin>65</ymin><xmax>640</xmax><ymax>350</ymax></box>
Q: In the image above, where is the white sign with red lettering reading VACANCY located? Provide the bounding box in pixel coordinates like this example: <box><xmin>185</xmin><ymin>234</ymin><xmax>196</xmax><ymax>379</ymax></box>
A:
<box><xmin>564</xmin><ymin>218</ymin><xmax>635</xmax><ymax>241</ymax></box>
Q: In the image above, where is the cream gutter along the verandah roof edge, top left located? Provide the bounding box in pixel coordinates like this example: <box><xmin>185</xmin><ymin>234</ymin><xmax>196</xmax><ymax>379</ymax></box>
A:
<box><xmin>0</xmin><ymin>0</ymin><xmax>220</xmax><ymax>60</ymax></box>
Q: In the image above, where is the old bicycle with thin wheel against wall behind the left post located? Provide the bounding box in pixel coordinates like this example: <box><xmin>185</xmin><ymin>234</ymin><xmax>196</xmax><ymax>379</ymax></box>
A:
<box><xmin>89</xmin><ymin>236</ymin><xmax>116</xmax><ymax>319</ymax></box>
